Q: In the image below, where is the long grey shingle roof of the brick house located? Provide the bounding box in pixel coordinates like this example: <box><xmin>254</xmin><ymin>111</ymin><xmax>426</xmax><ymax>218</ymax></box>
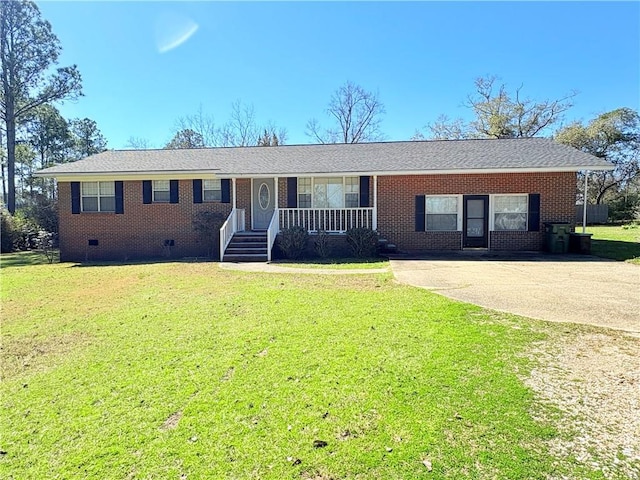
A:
<box><xmin>39</xmin><ymin>138</ymin><xmax>611</xmax><ymax>177</ymax></box>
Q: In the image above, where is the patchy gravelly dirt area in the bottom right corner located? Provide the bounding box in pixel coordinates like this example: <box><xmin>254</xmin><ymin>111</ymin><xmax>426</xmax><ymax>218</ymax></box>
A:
<box><xmin>526</xmin><ymin>329</ymin><xmax>640</xmax><ymax>479</ymax></box>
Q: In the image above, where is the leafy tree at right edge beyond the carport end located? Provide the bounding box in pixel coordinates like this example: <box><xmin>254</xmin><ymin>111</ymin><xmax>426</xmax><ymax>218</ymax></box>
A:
<box><xmin>555</xmin><ymin>108</ymin><xmax>640</xmax><ymax>203</ymax></box>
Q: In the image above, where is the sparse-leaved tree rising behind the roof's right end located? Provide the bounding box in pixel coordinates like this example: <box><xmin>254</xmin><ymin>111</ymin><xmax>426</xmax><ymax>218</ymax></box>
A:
<box><xmin>418</xmin><ymin>76</ymin><xmax>577</xmax><ymax>140</ymax></box>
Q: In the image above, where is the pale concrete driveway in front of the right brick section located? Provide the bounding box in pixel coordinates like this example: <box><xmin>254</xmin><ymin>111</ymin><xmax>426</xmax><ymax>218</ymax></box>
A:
<box><xmin>391</xmin><ymin>252</ymin><xmax>640</xmax><ymax>335</ymax></box>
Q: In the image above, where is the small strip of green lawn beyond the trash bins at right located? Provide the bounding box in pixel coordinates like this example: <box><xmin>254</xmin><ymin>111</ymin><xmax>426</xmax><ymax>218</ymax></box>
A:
<box><xmin>576</xmin><ymin>224</ymin><xmax>640</xmax><ymax>265</ymax></box>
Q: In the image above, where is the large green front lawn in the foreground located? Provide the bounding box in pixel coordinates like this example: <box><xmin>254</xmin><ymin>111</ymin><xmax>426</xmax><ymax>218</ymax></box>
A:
<box><xmin>0</xmin><ymin>257</ymin><xmax>602</xmax><ymax>480</ymax></box>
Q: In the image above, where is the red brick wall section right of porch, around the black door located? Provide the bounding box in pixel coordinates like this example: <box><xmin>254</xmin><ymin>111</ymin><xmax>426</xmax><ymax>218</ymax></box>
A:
<box><xmin>378</xmin><ymin>172</ymin><xmax>576</xmax><ymax>251</ymax></box>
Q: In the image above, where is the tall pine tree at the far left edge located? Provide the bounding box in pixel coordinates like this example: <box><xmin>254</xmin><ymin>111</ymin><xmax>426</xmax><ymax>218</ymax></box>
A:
<box><xmin>0</xmin><ymin>0</ymin><xmax>82</xmax><ymax>214</ymax></box>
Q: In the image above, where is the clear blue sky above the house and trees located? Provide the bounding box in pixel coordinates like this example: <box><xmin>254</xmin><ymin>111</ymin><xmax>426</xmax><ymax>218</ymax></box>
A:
<box><xmin>37</xmin><ymin>1</ymin><xmax>640</xmax><ymax>148</ymax></box>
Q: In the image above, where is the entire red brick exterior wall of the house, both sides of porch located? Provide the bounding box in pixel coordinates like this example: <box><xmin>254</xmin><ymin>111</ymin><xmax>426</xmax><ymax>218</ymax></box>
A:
<box><xmin>58</xmin><ymin>172</ymin><xmax>576</xmax><ymax>261</ymax></box>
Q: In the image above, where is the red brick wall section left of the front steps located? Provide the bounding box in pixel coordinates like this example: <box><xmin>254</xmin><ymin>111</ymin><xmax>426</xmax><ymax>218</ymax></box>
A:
<box><xmin>58</xmin><ymin>180</ymin><xmax>242</xmax><ymax>261</ymax></box>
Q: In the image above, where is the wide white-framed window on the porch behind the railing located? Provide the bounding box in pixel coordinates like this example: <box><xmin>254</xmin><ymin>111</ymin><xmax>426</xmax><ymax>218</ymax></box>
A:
<box><xmin>298</xmin><ymin>177</ymin><xmax>360</xmax><ymax>208</ymax></box>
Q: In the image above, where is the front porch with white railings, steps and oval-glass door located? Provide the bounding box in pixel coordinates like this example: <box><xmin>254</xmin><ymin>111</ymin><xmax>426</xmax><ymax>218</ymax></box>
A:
<box><xmin>220</xmin><ymin>175</ymin><xmax>377</xmax><ymax>261</ymax></box>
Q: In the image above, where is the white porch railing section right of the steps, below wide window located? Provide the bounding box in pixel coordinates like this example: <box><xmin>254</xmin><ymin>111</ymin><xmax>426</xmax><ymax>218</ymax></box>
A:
<box><xmin>277</xmin><ymin>207</ymin><xmax>376</xmax><ymax>233</ymax></box>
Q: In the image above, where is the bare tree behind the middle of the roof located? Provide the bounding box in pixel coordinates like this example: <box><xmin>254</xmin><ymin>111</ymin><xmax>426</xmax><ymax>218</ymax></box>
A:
<box><xmin>305</xmin><ymin>82</ymin><xmax>385</xmax><ymax>143</ymax></box>
